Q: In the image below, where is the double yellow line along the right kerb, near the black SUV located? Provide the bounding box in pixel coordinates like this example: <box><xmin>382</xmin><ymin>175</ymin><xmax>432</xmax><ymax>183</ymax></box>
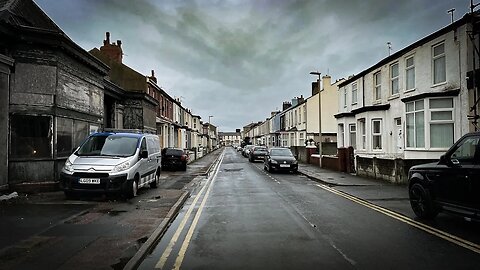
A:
<box><xmin>317</xmin><ymin>184</ymin><xmax>480</xmax><ymax>254</ymax></box>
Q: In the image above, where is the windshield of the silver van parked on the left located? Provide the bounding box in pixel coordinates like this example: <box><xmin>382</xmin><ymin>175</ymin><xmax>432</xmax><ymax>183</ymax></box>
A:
<box><xmin>77</xmin><ymin>135</ymin><xmax>138</xmax><ymax>157</ymax></box>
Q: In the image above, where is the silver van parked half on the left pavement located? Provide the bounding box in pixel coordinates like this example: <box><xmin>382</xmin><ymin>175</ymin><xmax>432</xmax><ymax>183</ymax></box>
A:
<box><xmin>60</xmin><ymin>132</ymin><xmax>161</xmax><ymax>198</ymax></box>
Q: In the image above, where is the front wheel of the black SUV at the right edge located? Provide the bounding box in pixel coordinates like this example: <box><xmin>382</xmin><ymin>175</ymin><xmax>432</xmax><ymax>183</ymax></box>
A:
<box><xmin>409</xmin><ymin>183</ymin><xmax>438</xmax><ymax>219</ymax></box>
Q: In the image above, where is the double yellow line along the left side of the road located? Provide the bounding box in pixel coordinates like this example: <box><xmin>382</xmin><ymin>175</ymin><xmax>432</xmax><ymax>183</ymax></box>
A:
<box><xmin>155</xmin><ymin>153</ymin><xmax>224</xmax><ymax>269</ymax></box>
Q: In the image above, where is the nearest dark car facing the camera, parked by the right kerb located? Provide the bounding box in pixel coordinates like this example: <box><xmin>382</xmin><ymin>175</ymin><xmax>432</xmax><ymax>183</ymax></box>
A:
<box><xmin>263</xmin><ymin>147</ymin><xmax>298</xmax><ymax>173</ymax></box>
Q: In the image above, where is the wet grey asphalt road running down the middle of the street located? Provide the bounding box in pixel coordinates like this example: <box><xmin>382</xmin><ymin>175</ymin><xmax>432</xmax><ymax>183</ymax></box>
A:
<box><xmin>139</xmin><ymin>148</ymin><xmax>480</xmax><ymax>269</ymax></box>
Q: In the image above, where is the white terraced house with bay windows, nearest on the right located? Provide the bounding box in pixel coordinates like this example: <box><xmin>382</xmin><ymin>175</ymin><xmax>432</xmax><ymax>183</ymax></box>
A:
<box><xmin>335</xmin><ymin>11</ymin><xmax>478</xmax><ymax>182</ymax></box>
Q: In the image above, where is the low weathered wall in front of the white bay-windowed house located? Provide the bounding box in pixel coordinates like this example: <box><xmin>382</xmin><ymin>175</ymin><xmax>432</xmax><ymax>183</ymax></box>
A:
<box><xmin>356</xmin><ymin>156</ymin><xmax>438</xmax><ymax>184</ymax></box>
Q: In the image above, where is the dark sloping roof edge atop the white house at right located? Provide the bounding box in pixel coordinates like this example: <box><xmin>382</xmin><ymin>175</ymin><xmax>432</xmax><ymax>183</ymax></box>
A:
<box><xmin>338</xmin><ymin>13</ymin><xmax>470</xmax><ymax>87</ymax></box>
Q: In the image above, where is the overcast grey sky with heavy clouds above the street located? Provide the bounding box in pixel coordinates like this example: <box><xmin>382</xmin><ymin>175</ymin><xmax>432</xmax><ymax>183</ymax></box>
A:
<box><xmin>35</xmin><ymin>0</ymin><xmax>470</xmax><ymax>131</ymax></box>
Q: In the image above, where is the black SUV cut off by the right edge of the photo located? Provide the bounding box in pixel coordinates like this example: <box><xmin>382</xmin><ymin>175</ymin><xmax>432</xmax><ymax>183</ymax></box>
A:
<box><xmin>408</xmin><ymin>132</ymin><xmax>480</xmax><ymax>220</ymax></box>
